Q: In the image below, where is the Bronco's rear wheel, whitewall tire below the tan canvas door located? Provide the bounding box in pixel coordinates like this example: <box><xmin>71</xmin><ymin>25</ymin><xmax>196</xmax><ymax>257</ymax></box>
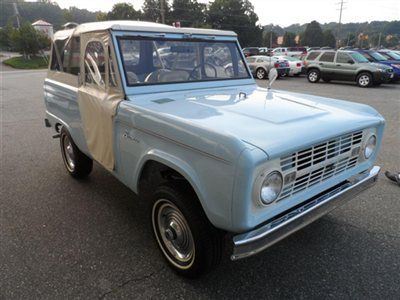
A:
<box><xmin>60</xmin><ymin>127</ymin><xmax>93</xmax><ymax>178</ymax></box>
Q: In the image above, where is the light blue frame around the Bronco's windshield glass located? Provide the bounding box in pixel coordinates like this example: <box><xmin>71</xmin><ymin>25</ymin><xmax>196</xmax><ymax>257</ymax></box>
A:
<box><xmin>113</xmin><ymin>31</ymin><xmax>254</xmax><ymax>89</ymax></box>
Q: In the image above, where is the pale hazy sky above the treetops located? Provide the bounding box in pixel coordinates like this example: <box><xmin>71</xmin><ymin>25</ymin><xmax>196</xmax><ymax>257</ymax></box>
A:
<box><xmin>56</xmin><ymin>0</ymin><xmax>400</xmax><ymax>26</ymax></box>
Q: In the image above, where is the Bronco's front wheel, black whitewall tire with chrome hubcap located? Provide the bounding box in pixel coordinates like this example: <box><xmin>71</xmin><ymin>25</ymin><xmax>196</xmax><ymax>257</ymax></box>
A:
<box><xmin>151</xmin><ymin>183</ymin><xmax>224</xmax><ymax>278</ymax></box>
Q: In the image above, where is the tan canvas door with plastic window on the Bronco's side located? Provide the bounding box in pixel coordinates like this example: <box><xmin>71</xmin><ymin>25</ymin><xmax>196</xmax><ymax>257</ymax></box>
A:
<box><xmin>78</xmin><ymin>32</ymin><xmax>123</xmax><ymax>171</ymax></box>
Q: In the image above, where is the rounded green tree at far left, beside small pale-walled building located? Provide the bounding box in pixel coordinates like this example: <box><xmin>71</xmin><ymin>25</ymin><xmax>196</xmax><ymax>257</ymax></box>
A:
<box><xmin>10</xmin><ymin>22</ymin><xmax>50</xmax><ymax>58</ymax></box>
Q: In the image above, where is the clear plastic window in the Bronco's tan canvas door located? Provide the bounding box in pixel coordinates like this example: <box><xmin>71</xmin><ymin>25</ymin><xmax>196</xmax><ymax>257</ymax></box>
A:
<box><xmin>85</xmin><ymin>41</ymin><xmax>106</xmax><ymax>88</ymax></box>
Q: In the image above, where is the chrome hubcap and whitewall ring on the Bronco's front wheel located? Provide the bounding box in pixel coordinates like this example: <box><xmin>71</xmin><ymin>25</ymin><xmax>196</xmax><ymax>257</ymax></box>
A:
<box><xmin>152</xmin><ymin>199</ymin><xmax>195</xmax><ymax>269</ymax></box>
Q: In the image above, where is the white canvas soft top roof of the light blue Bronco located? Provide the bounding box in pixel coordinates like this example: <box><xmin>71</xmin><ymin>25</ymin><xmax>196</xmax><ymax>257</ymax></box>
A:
<box><xmin>54</xmin><ymin>21</ymin><xmax>237</xmax><ymax>40</ymax></box>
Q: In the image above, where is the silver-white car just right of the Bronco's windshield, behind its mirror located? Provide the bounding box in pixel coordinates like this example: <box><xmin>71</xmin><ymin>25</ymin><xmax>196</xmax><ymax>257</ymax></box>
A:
<box><xmin>246</xmin><ymin>55</ymin><xmax>290</xmax><ymax>79</ymax></box>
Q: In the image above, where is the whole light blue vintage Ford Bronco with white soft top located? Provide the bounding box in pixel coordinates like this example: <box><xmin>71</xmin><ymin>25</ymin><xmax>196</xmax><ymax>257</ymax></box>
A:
<box><xmin>44</xmin><ymin>21</ymin><xmax>385</xmax><ymax>277</ymax></box>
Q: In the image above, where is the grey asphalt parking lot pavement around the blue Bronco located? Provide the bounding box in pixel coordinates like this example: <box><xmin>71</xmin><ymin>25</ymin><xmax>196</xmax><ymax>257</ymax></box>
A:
<box><xmin>0</xmin><ymin>71</ymin><xmax>400</xmax><ymax>299</ymax></box>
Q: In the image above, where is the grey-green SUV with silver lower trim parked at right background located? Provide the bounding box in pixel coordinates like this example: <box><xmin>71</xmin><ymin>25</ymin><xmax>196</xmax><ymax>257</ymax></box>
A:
<box><xmin>304</xmin><ymin>50</ymin><xmax>394</xmax><ymax>87</ymax></box>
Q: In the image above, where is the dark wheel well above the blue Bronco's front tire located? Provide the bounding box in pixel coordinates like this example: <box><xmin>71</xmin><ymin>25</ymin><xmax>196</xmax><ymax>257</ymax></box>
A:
<box><xmin>138</xmin><ymin>160</ymin><xmax>194</xmax><ymax>196</ymax></box>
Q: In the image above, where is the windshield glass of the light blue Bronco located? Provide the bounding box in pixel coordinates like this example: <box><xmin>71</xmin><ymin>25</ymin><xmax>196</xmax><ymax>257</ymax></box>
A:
<box><xmin>118</xmin><ymin>37</ymin><xmax>250</xmax><ymax>86</ymax></box>
